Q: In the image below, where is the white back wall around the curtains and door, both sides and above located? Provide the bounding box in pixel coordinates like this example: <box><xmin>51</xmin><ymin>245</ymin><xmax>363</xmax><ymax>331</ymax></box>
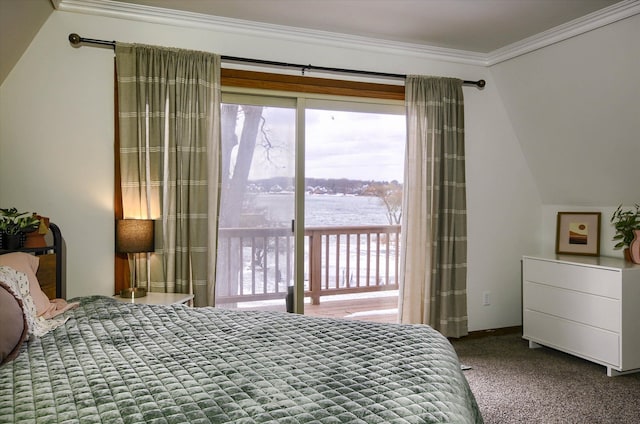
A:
<box><xmin>0</xmin><ymin>11</ymin><xmax>541</xmax><ymax>330</ymax></box>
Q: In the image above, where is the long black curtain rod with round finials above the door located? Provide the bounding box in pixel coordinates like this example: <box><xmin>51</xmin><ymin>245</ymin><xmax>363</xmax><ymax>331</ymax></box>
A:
<box><xmin>69</xmin><ymin>33</ymin><xmax>487</xmax><ymax>88</ymax></box>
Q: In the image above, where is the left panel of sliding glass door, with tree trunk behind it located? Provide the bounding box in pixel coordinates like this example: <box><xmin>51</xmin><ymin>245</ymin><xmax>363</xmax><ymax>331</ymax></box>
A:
<box><xmin>216</xmin><ymin>95</ymin><xmax>296</xmax><ymax>311</ymax></box>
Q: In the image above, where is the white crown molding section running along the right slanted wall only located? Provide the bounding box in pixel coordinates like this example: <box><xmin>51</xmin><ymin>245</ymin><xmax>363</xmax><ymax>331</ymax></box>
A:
<box><xmin>486</xmin><ymin>0</ymin><xmax>640</xmax><ymax>66</ymax></box>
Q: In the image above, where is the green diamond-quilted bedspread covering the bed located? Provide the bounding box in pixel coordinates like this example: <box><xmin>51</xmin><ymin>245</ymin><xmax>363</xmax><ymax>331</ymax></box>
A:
<box><xmin>0</xmin><ymin>227</ymin><xmax>482</xmax><ymax>423</ymax></box>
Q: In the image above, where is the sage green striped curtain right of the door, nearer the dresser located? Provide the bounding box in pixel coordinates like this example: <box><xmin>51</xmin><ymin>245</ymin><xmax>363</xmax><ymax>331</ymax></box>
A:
<box><xmin>399</xmin><ymin>76</ymin><xmax>468</xmax><ymax>337</ymax></box>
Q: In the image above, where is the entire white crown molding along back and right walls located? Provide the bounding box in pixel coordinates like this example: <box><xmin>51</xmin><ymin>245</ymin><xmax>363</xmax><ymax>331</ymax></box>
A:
<box><xmin>52</xmin><ymin>0</ymin><xmax>640</xmax><ymax>66</ymax></box>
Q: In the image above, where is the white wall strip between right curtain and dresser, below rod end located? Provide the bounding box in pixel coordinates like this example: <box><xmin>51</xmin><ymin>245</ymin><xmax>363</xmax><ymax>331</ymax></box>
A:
<box><xmin>465</xmin><ymin>73</ymin><xmax>541</xmax><ymax>331</ymax></box>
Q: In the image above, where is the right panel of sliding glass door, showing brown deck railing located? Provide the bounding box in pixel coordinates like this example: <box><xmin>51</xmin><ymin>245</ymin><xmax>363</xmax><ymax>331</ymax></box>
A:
<box><xmin>304</xmin><ymin>100</ymin><xmax>406</xmax><ymax>322</ymax></box>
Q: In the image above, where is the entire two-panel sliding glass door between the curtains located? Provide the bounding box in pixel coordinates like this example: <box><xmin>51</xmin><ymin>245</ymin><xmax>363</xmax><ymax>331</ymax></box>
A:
<box><xmin>216</xmin><ymin>93</ymin><xmax>405</xmax><ymax>322</ymax></box>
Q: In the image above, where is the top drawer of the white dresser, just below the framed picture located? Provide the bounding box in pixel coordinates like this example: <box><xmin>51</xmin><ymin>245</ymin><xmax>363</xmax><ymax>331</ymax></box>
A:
<box><xmin>523</xmin><ymin>258</ymin><xmax>622</xmax><ymax>299</ymax></box>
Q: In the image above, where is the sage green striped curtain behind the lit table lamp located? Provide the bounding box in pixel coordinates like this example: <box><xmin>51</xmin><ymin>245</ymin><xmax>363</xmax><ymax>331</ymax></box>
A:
<box><xmin>116</xmin><ymin>43</ymin><xmax>220</xmax><ymax>306</ymax></box>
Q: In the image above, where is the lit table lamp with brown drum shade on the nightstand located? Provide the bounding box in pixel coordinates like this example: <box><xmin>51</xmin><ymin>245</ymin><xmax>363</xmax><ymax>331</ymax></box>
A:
<box><xmin>116</xmin><ymin>219</ymin><xmax>154</xmax><ymax>298</ymax></box>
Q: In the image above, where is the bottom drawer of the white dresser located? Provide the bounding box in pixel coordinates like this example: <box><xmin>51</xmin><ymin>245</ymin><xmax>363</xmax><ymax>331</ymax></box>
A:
<box><xmin>523</xmin><ymin>310</ymin><xmax>620</xmax><ymax>367</ymax></box>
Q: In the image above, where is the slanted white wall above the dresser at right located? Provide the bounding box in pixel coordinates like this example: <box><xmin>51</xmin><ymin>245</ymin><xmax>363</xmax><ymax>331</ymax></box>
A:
<box><xmin>491</xmin><ymin>15</ymin><xmax>640</xmax><ymax>207</ymax></box>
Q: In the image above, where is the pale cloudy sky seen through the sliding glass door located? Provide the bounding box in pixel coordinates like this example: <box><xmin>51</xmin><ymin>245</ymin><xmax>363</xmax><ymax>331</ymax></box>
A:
<box><xmin>240</xmin><ymin>107</ymin><xmax>406</xmax><ymax>182</ymax></box>
